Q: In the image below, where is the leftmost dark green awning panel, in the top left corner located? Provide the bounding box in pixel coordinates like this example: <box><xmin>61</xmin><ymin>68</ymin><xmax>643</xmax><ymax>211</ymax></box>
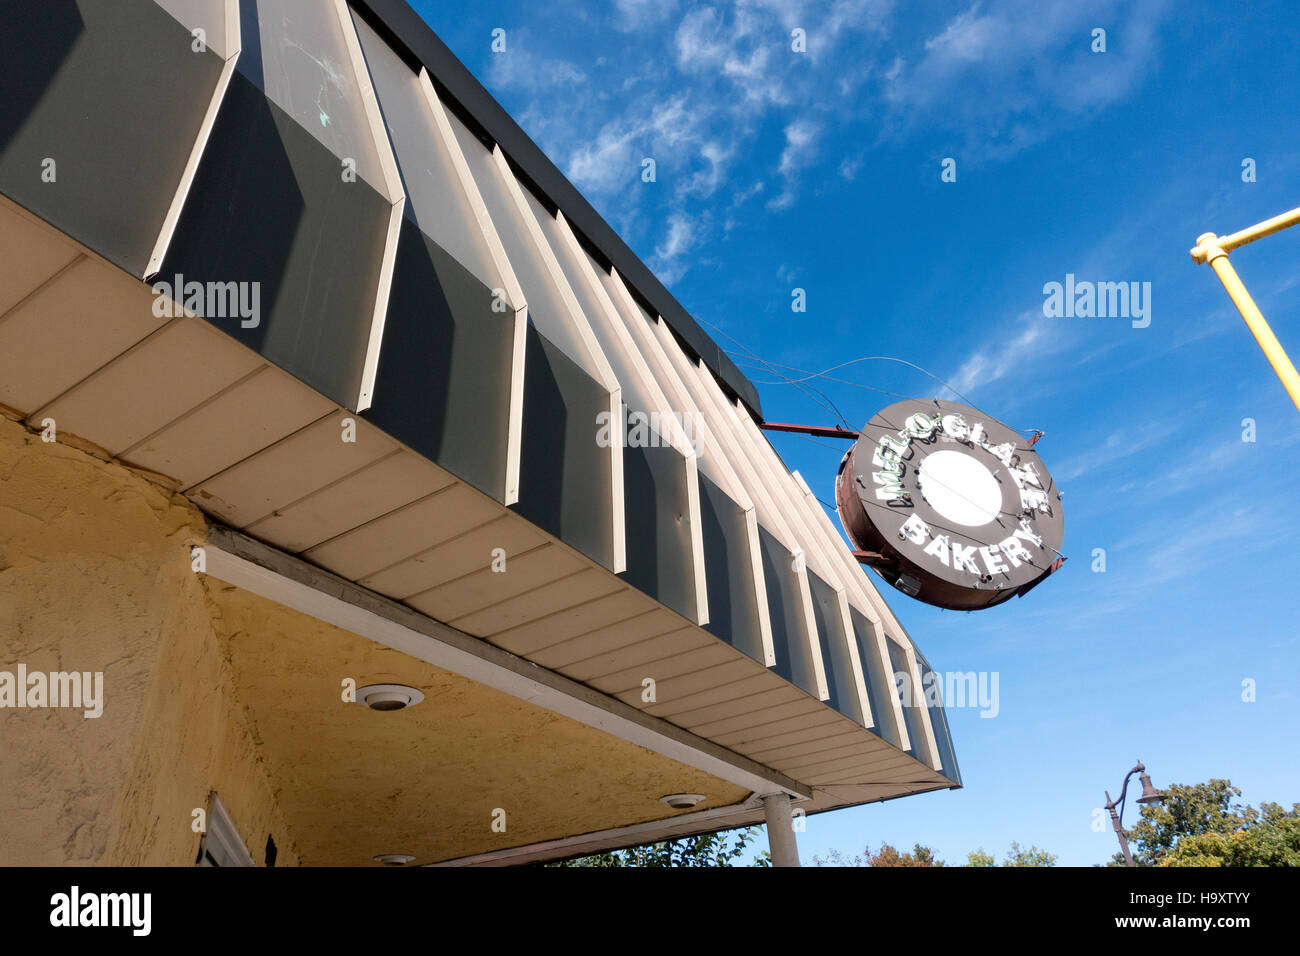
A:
<box><xmin>0</xmin><ymin>0</ymin><xmax>222</xmax><ymax>276</ymax></box>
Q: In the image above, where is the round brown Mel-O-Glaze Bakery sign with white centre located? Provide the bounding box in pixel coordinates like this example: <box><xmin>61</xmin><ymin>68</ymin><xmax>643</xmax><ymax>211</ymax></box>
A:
<box><xmin>835</xmin><ymin>398</ymin><xmax>1065</xmax><ymax>610</ymax></box>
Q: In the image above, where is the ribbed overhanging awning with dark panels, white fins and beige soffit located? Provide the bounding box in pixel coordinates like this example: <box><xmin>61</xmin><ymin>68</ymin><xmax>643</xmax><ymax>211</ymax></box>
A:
<box><xmin>0</xmin><ymin>0</ymin><xmax>961</xmax><ymax>852</ymax></box>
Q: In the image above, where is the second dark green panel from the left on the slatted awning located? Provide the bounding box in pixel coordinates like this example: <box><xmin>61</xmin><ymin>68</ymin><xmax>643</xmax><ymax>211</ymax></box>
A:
<box><xmin>157</xmin><ymin>70</ymin><xmax>391</xmax><ymax>408</ymax></box>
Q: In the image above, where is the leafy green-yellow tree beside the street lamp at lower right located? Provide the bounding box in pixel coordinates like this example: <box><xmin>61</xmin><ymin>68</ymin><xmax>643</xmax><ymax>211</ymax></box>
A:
<box><xmin>1110</xmin><ymin>779</ymin><xmax>1300</xmax><ymax>866</ymax></box>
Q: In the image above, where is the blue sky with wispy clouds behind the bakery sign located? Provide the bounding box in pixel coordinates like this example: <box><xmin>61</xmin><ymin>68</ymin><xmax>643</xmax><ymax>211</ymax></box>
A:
<box><xmin>415</xmin><ymin>0</ymin><xmax>1300</xmax><ymax>865</ymax></box>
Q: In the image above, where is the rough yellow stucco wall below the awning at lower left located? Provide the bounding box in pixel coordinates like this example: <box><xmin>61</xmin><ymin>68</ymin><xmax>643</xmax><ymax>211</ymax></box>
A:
<box><xmin>0</xmin><ymin>419</ymin><xmax>298</xmax><ymax>865</ymax></box>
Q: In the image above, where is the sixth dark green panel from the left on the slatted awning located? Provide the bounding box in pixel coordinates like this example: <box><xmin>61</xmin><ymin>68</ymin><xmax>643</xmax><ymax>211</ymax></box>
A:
<box><xmin>699</xmin><ymin>472</ymin><xmax>766</xmax><ymax>663</ymax></box>
